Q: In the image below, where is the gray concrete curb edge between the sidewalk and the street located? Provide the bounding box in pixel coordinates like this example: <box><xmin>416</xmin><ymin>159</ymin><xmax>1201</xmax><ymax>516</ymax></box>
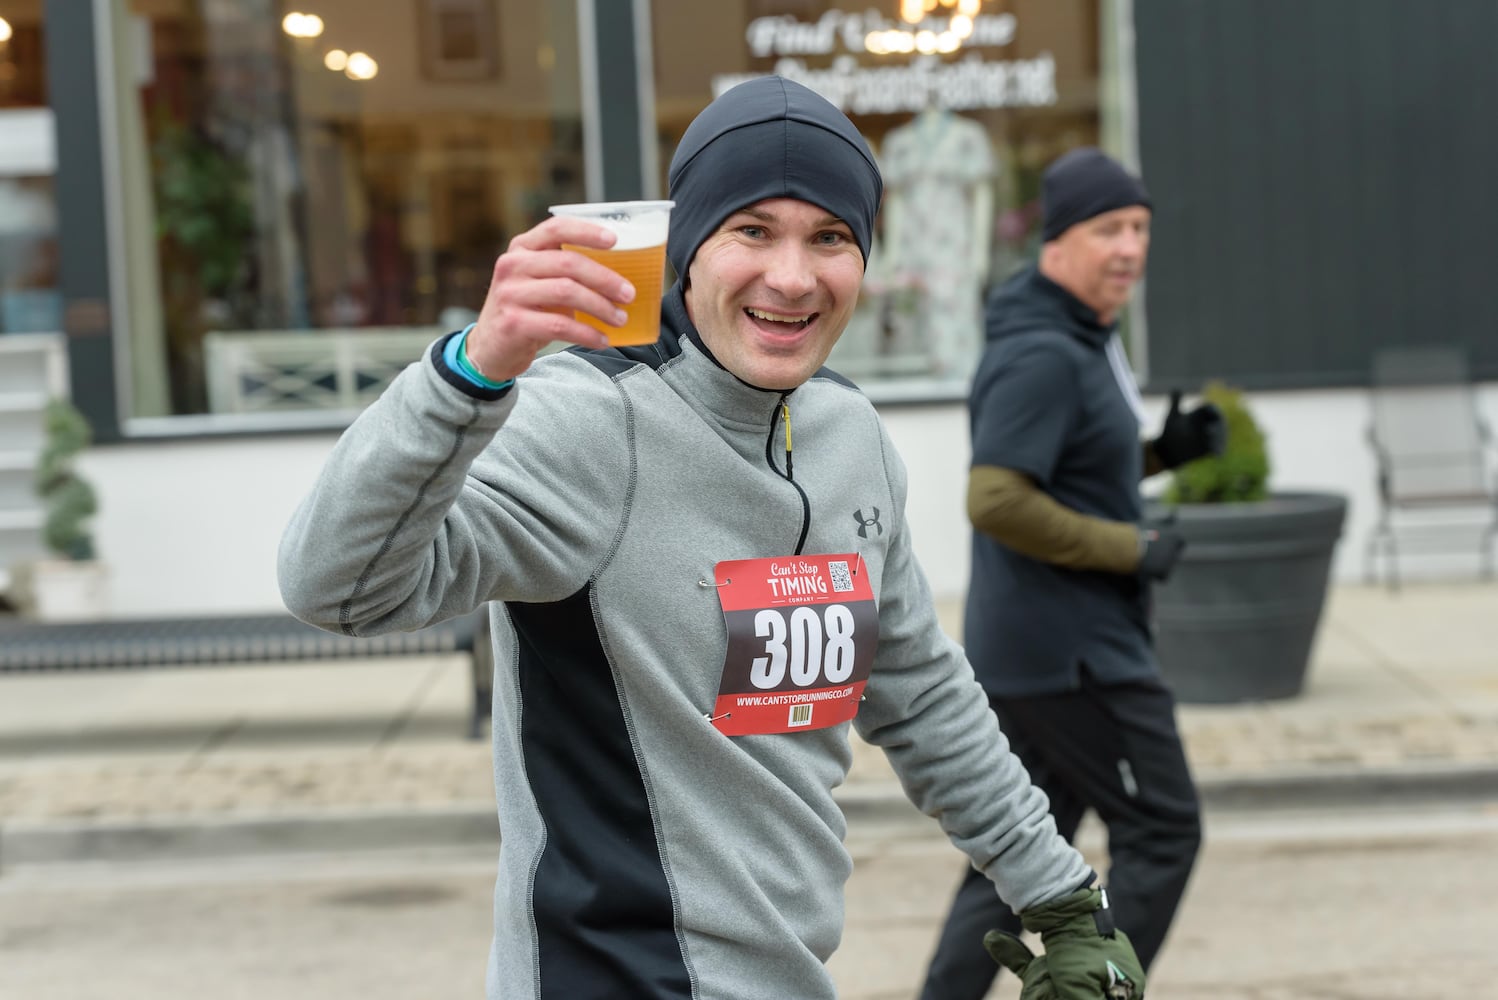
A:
<box><xmin>0</xmin><ymin>762</ymin><xmax>1498</xmax><ymax>873</ymax></box>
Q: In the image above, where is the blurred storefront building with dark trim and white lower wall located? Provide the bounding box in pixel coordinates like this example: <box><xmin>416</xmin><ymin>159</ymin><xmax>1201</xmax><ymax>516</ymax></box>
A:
<box><xmin>0</xmin><ymin>0</ymin><xmax>1498</xmax><ymax>615</ymax></box>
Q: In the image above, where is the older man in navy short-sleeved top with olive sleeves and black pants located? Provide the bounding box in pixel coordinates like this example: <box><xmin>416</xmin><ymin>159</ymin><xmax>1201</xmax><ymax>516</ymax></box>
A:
<box><xmin>921</xmin><ymin>148</ymin><xmax>1225</xmax><ymax>1000</ymax></box>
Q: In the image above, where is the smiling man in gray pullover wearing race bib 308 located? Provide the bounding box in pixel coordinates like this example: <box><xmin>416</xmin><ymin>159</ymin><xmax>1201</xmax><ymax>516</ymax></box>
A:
<box><xmin>280</xmin><ymin>78</ymin><xmax>1143</xmax><ymax>1000</ymax></box>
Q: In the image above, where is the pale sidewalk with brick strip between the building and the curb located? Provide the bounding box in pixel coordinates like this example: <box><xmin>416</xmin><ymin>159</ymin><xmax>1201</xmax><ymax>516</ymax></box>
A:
<box><xmin>0</xmin><ymin>584</ymin><xmax>1498</xmax><ymax>864</ymax></box>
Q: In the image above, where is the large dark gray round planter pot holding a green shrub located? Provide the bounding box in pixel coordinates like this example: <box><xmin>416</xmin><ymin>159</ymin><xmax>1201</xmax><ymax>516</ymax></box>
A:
<box><xmin>1149</xmin><ymin>493</ymin><xmax>1347</xmax><ymax>704</ymax></box>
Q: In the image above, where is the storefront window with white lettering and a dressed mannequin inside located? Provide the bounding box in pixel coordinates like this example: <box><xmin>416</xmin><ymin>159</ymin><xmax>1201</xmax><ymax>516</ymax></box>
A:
<box><xmin>652</xmin><ymin>0</ymin><xmax>1104</xmax><ymax>398</ymax></box>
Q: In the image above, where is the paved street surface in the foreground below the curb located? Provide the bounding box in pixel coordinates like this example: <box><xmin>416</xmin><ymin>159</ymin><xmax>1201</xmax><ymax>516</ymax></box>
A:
<box><xmin>0</xmin><ymin>802</ymin><xmax>1498</xmax><ymax>1000</ymax></box>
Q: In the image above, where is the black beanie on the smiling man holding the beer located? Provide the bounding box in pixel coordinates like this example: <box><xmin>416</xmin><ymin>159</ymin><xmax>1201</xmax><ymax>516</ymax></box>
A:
<box><xmin>665</xmin><ymin>76</ymin><xmax>884</xmax><ymax>280</ymax></box>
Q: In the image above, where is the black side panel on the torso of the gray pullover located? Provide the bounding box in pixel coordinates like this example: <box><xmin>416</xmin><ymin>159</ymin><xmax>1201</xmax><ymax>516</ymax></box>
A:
<box><xmin>502</xmin><ymin>587</ymin><xmax>692</xmax><ymax>1000</ymax></box>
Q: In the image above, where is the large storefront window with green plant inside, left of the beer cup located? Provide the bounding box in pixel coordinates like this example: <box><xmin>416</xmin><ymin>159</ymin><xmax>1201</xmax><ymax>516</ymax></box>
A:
<box><xmin>111</xmin><ymin>0</ymin><xmax>584</xmax><ymax>418</ymax></box>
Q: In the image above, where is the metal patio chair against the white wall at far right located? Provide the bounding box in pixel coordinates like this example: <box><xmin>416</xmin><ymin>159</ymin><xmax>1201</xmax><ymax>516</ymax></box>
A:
<box><xmin>1366</xmin><ymin>347</ymin><xmax>1498</xmax><ymax>590</ymax></box>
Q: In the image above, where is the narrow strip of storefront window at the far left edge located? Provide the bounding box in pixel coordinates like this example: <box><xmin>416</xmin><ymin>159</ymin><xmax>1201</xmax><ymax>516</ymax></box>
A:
<box><xmin>0</xmin><ymin>0</ymin><xmax>63</xmax><ymax>335</ymax></box>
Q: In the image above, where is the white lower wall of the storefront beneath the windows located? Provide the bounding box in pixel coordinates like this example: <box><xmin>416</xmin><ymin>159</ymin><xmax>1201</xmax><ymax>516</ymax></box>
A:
<box><xmin>84</xmin><ymin>383</ymin><xmax>1498</xmax><ymax>617</ymax></box>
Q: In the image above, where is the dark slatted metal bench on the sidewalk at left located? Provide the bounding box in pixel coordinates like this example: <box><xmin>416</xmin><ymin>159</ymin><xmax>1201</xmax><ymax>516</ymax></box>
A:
<box><xmin>0</xmin><ymin>608</ymin><xmax>494</xmax><ymax>740</ymax></box>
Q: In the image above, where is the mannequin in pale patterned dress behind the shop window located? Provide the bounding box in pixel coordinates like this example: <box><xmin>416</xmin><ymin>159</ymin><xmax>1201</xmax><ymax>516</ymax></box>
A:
<box><xmin>879</xmin><ymin>103</ymin><xmax>995</xmax><ymax>377</ymax></box>
